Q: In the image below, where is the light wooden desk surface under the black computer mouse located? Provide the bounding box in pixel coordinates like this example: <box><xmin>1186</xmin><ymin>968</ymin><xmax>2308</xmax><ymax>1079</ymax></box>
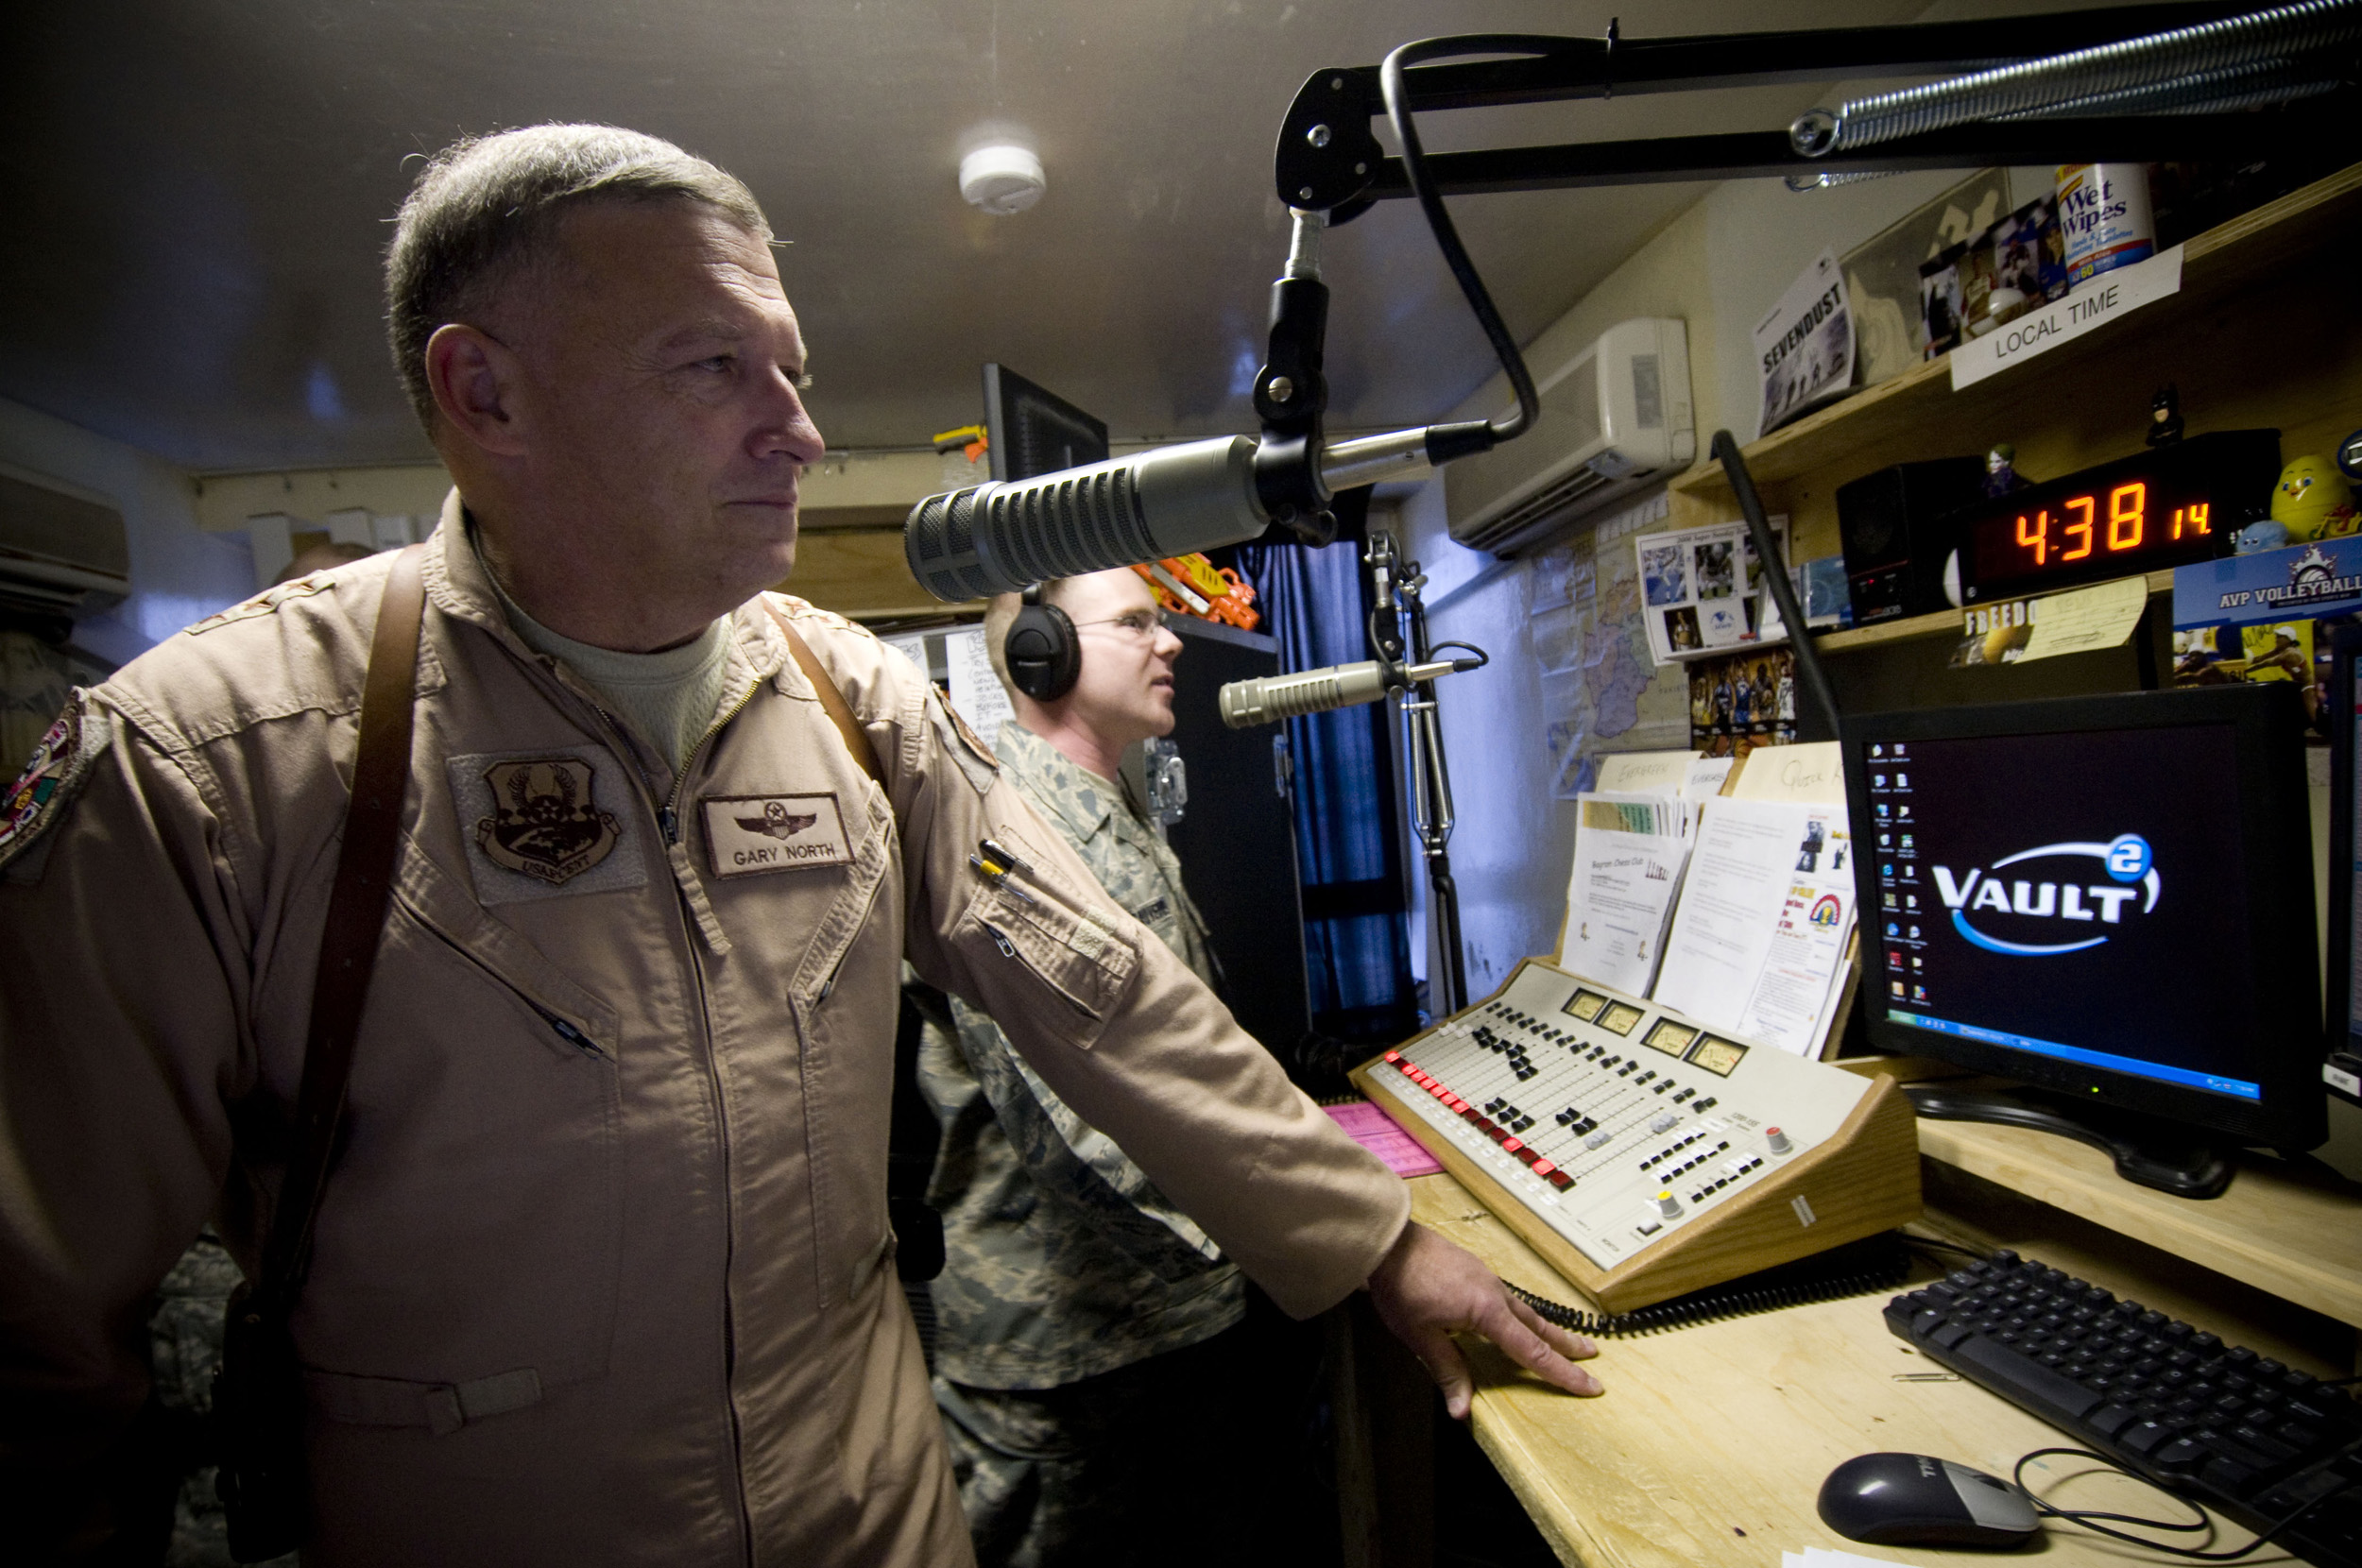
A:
<box><xmin>1411</xmin><ymin>1176</ymin><xmax>2294</xmax><ymax>1568</ymax></box>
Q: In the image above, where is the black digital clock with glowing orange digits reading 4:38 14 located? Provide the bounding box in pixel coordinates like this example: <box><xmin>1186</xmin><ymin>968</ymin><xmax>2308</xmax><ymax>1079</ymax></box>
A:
<box><xmin>1956</xmin><ymin>430</ymin><xmax>2280</xmax><ymax>605</ymax></box>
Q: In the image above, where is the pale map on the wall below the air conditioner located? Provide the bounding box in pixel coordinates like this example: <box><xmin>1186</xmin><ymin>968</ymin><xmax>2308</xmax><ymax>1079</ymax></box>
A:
<box><xmin>1529</xmin><ymin>494</ymin><xmax>1689</xmax><ymax>801</ymax></box>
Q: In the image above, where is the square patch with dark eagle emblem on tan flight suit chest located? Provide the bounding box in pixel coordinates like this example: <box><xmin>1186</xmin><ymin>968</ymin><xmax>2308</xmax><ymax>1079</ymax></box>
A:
<box><xmin>444</xmin><ymin>746</ymin><xmax>647</xmax><ymax>905</ymax></box>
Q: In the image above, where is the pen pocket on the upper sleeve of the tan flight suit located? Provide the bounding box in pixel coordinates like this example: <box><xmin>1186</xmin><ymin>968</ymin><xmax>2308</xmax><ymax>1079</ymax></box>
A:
<box><xmin>959</xmin><ymin>883</ymin><xmax>1141</xmax><ymax>1051</ymax></box>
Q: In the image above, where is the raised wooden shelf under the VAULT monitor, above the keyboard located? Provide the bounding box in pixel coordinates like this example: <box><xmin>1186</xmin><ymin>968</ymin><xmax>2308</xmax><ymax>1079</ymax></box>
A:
<box><xmin>1918</xmin><ymin>1122</ymin><xmax>2362</xmax><ymax>1327</ymax></box>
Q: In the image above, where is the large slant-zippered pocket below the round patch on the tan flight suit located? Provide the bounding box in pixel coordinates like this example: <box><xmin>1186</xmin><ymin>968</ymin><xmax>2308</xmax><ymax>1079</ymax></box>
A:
<box><xmin>296</xmin><ymin>855</ymin><xmax>624</xmax><ymax>1431</ymax></box>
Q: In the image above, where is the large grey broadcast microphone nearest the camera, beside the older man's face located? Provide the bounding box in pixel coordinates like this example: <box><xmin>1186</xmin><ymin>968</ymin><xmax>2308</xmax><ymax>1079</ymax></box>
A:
<box><xmin>902</xmin><ymin>420</ymin><xmax>1491</xmax><ymax>602</ymax></box>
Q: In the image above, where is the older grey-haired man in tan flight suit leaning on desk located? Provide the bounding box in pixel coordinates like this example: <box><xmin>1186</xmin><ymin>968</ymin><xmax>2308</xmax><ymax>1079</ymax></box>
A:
<box><xmin>0</xmin><ymin>128</ymin><xmax>1597</xmax><ymax>1568</ymax></box>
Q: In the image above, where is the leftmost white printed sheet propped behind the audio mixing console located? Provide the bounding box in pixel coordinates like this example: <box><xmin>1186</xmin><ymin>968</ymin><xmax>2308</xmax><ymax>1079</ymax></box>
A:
<box><xmin>1559</xmin><ymin>793</ymin><xmax>1689</xmax><ymax>997</ymax></box>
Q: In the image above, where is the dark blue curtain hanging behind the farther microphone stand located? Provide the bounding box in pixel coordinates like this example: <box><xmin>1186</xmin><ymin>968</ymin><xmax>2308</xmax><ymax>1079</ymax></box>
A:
<box><xmin>1241</xmin><ymin>538</ymin><xmax>1417</xmax><ymax>1042</ymax></box>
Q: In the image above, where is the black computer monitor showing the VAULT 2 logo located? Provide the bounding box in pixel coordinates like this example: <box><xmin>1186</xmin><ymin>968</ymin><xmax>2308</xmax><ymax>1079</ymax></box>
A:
<box><xmin>1842</xmin><ymin>685</ymin><xmax>2327</xmax><ymax>1195</ymax></box>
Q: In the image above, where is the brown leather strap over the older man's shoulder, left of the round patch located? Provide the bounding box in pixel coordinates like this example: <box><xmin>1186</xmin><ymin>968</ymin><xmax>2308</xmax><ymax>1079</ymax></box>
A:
<box><xmin>258</xmin><ymin>546</ymin><xmax>428</xmax><ymax>1313</ymax></box>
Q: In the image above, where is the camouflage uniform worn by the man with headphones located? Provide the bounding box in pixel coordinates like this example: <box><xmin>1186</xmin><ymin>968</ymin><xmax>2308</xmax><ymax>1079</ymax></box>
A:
<box><xmin>919</xmin><ymin>721</ymin><xmax>1245</xmax><ymax>1563</ymax></box>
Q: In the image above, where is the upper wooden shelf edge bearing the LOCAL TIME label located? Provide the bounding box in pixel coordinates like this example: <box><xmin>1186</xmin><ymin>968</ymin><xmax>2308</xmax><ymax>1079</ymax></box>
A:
<box><xmin>1672</xmin><ymin>163</ymin><xmax>2362</xmax><ymax>503</ymax></box>
